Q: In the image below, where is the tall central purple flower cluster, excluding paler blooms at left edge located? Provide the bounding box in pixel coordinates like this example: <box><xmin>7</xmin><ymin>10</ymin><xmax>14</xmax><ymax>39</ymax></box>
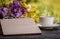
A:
<box><xmin>10</xmin><ymin>0</ymin><xmax>22</xmax><ymax>17</ymax></box>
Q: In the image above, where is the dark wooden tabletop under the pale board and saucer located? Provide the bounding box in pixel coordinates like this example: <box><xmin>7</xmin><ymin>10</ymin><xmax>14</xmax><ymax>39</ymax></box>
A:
<box><xmin>0</xmin><ymin>25</ymin><xmax>60</xmax><ymax>39</ymax></box>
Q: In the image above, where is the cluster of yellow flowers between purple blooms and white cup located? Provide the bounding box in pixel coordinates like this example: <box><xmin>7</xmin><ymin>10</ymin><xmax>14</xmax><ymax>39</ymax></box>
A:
<box><xmin>28</xmin><ymin>4</ymin><xmax>39</xmax><ymax>23</ymax></box>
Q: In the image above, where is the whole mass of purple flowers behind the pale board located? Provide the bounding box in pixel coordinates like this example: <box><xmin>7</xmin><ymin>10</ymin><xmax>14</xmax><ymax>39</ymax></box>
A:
<box><xmin>0</xmin><ymin>0</ymin><xmax>27</xmax><ymax>18</ymax></box>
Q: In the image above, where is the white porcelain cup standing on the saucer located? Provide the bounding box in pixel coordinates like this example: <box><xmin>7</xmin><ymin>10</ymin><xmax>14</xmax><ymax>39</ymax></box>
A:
<box><xmin>40</xmin><ymin>17</ymin><xmax>54</xmax><ymax>27</ymax></box>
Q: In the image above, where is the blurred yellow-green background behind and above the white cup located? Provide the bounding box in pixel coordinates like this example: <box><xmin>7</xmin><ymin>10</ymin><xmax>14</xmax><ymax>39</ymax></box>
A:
<box><xmin>27</xmin><ymin>0</ymin><xmax>60</xmax><ymax>23</ymax></box>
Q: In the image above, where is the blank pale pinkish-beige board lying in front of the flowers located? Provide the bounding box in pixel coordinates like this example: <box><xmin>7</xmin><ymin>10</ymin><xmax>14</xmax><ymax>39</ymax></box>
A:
<box><xmin>1</xmin><ymin>18</ymin><xmax>41</xmax><ymax>35</ymax></box>
